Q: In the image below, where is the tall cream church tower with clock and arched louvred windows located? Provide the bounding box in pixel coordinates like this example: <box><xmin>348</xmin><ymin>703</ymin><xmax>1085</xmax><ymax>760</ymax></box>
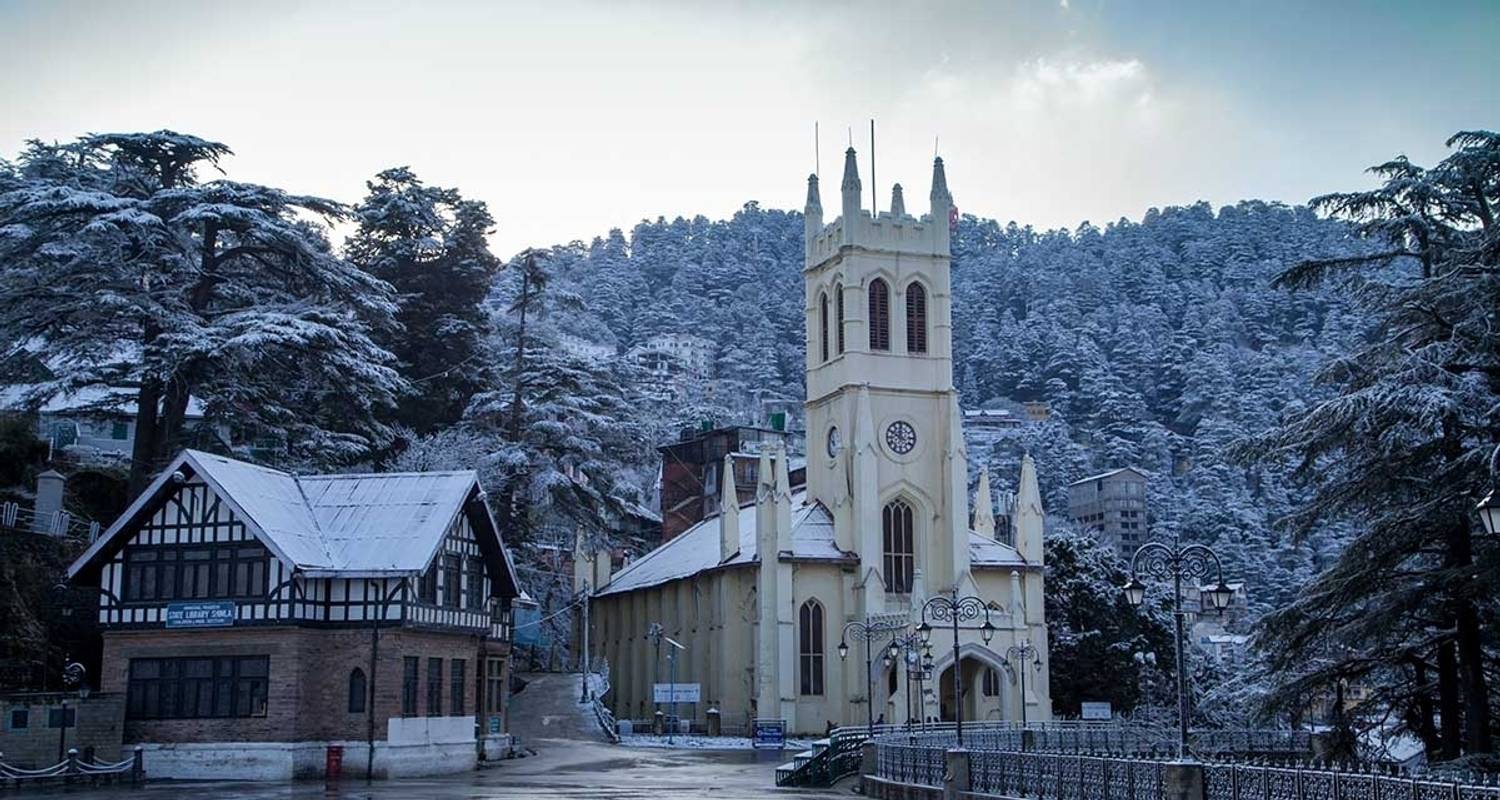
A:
<box><xmin>803</xmin><ymin>147</ymin><xmax>972</xmax><ymax>614</ymax></box>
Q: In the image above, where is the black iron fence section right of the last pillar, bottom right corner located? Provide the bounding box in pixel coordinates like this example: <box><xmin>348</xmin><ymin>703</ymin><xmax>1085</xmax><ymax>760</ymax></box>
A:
<box><xmin>1203</xmin><ymin>762</ymin><xmax>1500</xmax><ymax>800</ymax></box>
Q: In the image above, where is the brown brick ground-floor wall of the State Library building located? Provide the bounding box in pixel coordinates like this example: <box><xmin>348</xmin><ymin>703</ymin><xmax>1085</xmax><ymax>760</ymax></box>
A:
<box><xmin>101</xmin><ymin>627</ymin><xmax>498</xmax><ymax>743</ymax></box>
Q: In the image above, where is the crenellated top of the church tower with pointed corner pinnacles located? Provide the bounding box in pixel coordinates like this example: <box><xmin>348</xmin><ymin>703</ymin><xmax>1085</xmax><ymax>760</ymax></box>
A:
<box><xmin>804</xmin><ymin>147</ymin><xmax>953</xmax><ymax>269</ymax></box>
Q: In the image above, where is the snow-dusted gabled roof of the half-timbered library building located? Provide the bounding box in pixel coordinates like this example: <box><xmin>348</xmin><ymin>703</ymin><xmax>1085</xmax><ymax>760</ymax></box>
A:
<box><xmin>68</xmin><ymin>450</ymin><xmax>519</xmax><ymax>591</ymax></box>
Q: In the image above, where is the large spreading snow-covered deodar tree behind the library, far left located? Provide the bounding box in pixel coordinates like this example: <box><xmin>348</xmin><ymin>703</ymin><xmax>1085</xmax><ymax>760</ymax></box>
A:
<box><xmin>0</xmin><ymin>131</ymin><xmax>404</xmax><ymax>489</ymax></box>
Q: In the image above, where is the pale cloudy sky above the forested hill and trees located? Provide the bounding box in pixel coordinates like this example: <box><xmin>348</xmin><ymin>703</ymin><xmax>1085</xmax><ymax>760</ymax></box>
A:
<box><xmin>0</xmin><ymin>0</ymin><xmax>1500</xmax><ymax>257</ymax></box>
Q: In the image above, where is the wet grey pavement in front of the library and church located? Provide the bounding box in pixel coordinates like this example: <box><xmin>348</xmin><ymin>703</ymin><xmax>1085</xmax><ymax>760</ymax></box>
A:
<box><xmin>45</xmin><ymin>740</ymin><xmax>851</xmax><ymax>800</ymax></box>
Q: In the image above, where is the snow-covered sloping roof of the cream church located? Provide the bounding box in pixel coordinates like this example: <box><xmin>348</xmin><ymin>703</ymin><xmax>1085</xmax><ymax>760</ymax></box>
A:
<box><xmin>599</xmin><ymin>489</ymin><xmax>1026</xmax><ymax>596</ymax></box>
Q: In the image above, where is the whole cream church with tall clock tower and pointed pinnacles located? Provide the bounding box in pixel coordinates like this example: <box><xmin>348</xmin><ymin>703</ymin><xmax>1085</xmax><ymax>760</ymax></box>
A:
<box><xmin>575</xmin><ymin>147</ymin><xmax>1052</xmax><ymax>734</ymax></box>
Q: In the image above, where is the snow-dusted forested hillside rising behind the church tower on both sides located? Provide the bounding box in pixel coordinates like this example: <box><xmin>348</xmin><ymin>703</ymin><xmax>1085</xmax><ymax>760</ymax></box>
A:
<box><xmin>551</xmin><ymin>201</ymin><xmax>1364</xmax><ymax>609</ymax></box>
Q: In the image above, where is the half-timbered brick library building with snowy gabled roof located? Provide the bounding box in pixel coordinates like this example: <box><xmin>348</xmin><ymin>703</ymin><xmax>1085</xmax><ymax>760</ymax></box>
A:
<box><xmin>69</xmin><ymin>450</ymin><xmax>519</xmax><ymax>777</ymax></box>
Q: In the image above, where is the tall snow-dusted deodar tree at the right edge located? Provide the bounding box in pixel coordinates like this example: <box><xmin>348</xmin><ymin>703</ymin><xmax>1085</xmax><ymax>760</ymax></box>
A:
<box><xmin>1247</xmin><ymin>131</ymin><xmax>1500</xmax><ymax>758</ymax></box>
